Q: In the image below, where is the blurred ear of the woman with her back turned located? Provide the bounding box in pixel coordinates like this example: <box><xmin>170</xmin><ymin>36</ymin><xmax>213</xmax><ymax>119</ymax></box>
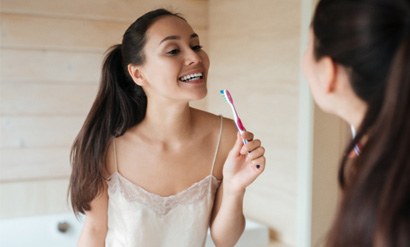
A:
<box><xmin>318</xmin><ymin>57</ymin><xmax>338</xmax><ymax>93</ymax></box>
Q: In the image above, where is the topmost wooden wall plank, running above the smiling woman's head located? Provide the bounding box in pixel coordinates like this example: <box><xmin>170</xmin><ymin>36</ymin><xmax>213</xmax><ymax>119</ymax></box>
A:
<box><xmin>1</xmin><ymin>0</ymin><xmax>208</xmax><ymax>27</ymax></box>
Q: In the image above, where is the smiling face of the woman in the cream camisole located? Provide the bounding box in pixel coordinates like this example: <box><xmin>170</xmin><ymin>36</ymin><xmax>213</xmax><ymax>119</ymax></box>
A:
<box><xmin>140</xmin><ymin>16</ymin><xmax>209</xmax><ymax>101</ymax></box>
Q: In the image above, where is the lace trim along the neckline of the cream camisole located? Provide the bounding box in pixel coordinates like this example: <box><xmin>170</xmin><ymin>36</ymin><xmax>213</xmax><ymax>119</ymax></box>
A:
<box><xmin>108</xmin><ymin>172</ymin><xmax>221</xmax><ymax>215</ymax></box>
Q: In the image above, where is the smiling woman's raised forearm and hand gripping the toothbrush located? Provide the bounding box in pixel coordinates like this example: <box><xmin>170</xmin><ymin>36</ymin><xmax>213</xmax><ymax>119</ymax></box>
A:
<box><xmin>211</xmin><ymin>132</ymin><xmax>265</xmax><ymax>247</ymax></box>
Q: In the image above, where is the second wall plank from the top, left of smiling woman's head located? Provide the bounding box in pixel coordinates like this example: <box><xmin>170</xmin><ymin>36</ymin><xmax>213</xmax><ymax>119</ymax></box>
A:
<box><xmin>0</xmin><ymin>14</ymin><xmax>129</xmax><ymax>53</ymax></box>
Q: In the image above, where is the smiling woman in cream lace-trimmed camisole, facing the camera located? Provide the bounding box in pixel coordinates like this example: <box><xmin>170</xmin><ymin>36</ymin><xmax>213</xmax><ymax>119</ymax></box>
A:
<box><xmin>70</xmin><ymin>9</ymin><xmax>265</xmax><ymax>246</ymax></box>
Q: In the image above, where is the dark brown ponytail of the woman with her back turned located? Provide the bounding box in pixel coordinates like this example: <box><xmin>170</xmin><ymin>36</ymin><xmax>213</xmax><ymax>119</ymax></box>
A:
<box><xmin>327</xmin><ymin>12</ymin><xmax>410</xmax><ymax>247</ymax></box>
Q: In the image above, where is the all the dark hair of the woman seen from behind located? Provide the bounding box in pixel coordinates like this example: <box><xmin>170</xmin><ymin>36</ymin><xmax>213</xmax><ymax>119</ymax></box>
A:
<box><xmin>312</xmin><ymin>0</ymin><xmax>410</xmax><ymax>244</ymax></box>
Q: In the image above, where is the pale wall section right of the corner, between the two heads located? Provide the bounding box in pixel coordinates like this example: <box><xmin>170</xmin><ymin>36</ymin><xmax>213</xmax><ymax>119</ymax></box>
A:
<box><xmin>207</xmin><ymin>0</ymin><xmax>347</xmax><ymax>247</ymax></box>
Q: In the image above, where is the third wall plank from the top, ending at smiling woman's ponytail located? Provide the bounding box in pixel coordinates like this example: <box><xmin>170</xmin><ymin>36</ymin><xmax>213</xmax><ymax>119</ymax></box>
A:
<box><xmin>0</xmin><ymin>49</ymin><xmax>103</xmax><ymax>83</ymax></box>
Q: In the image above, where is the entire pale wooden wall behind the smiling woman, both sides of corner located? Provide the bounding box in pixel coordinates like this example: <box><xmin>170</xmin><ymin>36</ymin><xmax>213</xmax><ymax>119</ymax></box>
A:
<box><xmin>0</xmin><ymin>0</ymin><xmax>344</xmax><ymax>247</ymax></box>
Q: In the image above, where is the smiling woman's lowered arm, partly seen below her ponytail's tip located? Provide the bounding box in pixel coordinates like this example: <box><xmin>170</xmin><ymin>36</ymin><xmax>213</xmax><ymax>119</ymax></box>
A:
<box><xmin>78</xmin><ymin>188</ymin><xmax>108</xmax><ymax>247</ymax></box>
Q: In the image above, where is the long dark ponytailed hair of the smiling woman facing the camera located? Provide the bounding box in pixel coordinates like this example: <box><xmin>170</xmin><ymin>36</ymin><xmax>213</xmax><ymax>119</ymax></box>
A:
<box><xmin>69</xmin><ymin>9</ymin><xmax>183</xmax><ymax>214</ymax></box>
